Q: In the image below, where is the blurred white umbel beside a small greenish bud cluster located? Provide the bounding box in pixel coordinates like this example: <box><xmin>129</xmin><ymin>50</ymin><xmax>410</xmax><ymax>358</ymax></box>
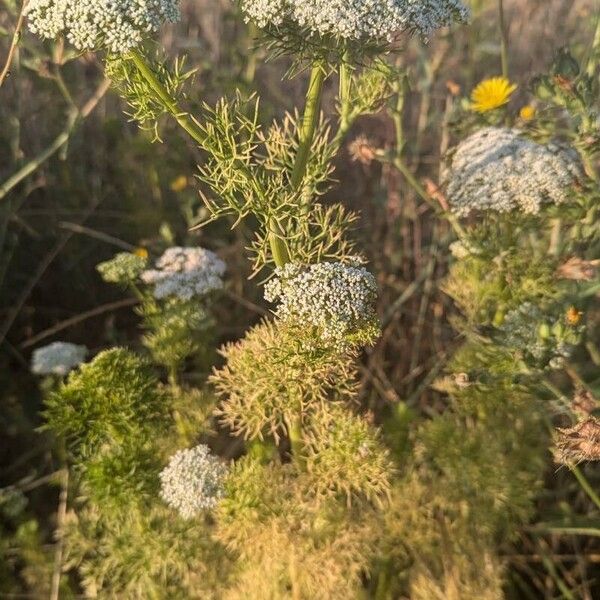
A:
<box><xmin>142</xmin><ymin>246</ymin><xmax>225</xmax><ymax>300</ymax></box>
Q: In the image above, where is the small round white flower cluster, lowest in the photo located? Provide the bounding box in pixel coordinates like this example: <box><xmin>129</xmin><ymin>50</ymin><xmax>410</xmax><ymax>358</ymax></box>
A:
<box><xmin>160</xmin><ymin>444</ymin><xmax>227</xmax><ymax>519</ymax></box>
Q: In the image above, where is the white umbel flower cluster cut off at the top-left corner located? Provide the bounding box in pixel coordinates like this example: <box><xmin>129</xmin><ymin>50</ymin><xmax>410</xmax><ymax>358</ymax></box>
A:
<box><xmin>26</xmin><ymin>0</ymin><xmax>179</xmax><ymax>54</ymax></box>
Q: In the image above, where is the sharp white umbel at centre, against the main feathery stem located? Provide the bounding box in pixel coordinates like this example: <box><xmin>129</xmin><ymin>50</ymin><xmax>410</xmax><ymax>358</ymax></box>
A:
<box><xmin>265</xmin><ymin>262</ymin><xmax>377</xmax><ymax>347</ymax></box>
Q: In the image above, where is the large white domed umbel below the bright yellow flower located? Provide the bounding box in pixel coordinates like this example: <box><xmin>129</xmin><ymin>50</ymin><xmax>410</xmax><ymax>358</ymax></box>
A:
<box><xmin>444</xmin><ymin>127</ymin><xmax>581</xmax><ymax>217</ymax></box>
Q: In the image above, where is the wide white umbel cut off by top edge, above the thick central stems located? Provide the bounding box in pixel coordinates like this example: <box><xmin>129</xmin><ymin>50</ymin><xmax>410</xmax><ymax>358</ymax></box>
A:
<box><xmin>241</xmin><ymin>0</ymin><xmax>469</xmax><ymax>40</ymax></box>
